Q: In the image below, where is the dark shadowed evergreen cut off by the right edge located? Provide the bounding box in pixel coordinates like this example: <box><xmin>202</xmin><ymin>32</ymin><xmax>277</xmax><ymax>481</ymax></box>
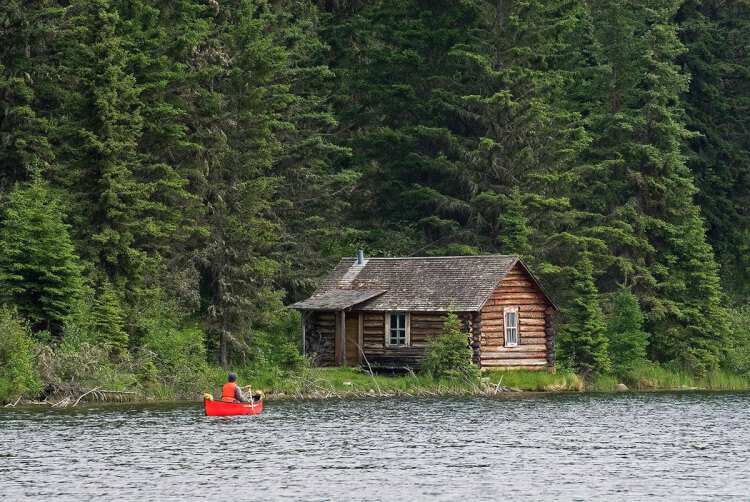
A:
<box><xmin>676</xmin><ymin>0</ymin><xmax>750</xmax><ymax>301</ymax></box>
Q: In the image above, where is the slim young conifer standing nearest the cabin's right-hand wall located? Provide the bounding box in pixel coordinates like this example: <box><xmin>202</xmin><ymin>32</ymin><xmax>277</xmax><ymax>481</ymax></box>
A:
<box><xmin>558</xmin><ymin>253</ymin><xmax>610</xmax><ymax>378</ymax></box>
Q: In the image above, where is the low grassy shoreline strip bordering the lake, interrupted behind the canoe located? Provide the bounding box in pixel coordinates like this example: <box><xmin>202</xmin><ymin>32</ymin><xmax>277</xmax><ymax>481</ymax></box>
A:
<box><xmin>0</xmin><ymin>368</ymin><xmax>750</xmax><ymax>409</ymax></box>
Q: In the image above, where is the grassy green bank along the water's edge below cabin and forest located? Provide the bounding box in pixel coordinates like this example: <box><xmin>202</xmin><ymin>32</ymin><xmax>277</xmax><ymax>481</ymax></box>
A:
<box><xmin>6</xmin><ymin>366</ymin><xmax>750</xmax><ymax>406</ymax></box>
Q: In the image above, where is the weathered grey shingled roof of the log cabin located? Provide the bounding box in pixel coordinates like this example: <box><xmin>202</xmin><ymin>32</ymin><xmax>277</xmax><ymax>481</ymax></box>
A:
<box><xmin>289</xmin><ymin>255</ymin><xmax>519</xmax><ymax>312</ymax></box>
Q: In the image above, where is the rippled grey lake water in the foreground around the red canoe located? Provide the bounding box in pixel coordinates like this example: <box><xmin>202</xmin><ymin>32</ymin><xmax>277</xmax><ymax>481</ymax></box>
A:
<box><xmin>0</xmin><ymin>393</ymin><xmax>750</xmax><ymax>501</ymax></box>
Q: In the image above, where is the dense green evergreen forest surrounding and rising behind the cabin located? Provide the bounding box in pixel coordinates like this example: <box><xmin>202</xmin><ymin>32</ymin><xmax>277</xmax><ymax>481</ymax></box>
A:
<box><xmin>0</xmin><ymin>0</ymin><xmax>750</xmax><ymax>400</ymax></box>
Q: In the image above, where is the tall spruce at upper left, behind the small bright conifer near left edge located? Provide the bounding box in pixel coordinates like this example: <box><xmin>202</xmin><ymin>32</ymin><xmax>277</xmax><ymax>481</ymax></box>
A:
<box><xmin>58</xmin><ymin>0</ymin><xmax>195</xmax><ymax>307</ymax></box>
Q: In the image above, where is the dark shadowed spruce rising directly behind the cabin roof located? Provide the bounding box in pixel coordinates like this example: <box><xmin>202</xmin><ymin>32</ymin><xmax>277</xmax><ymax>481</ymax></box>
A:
<box><xmin>326</xmin><ymin>1</ymin><xmax>488</xmax><ymax>255</ymax></box>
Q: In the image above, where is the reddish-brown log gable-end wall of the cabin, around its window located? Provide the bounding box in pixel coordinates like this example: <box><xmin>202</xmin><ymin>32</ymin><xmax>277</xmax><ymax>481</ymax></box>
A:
<box><xmin>479</xmin><ymin>264</ymin><xmax>554</xmax><ymax>369</ymax></box>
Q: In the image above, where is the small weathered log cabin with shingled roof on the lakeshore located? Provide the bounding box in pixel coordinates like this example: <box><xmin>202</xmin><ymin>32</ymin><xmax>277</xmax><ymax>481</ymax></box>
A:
<box><xmin>289</xmin><ymin>251</ymin><xmax>557</xmax><ymax>371</ymax></box>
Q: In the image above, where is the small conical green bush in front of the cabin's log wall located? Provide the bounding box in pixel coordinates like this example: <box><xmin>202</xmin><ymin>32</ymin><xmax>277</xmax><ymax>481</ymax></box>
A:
<box><xmin>422</xmin><ymin>312</ymin><xmax>478</xmax><ymax>378</ymax></box>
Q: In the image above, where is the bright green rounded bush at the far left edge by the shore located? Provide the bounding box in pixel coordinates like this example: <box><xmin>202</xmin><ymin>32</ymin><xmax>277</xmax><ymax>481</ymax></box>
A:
<box><xmin>0</xmin><ymin>307</ymin><xmax>42</xmax><ymax>401</ymax></box>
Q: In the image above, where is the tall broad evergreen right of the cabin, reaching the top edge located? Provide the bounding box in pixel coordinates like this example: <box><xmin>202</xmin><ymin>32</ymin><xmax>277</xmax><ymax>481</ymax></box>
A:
<box><xmin>572</xmin><ymin>0</ymin><xmax>728</xmax><ymax>372</ymax></box>
